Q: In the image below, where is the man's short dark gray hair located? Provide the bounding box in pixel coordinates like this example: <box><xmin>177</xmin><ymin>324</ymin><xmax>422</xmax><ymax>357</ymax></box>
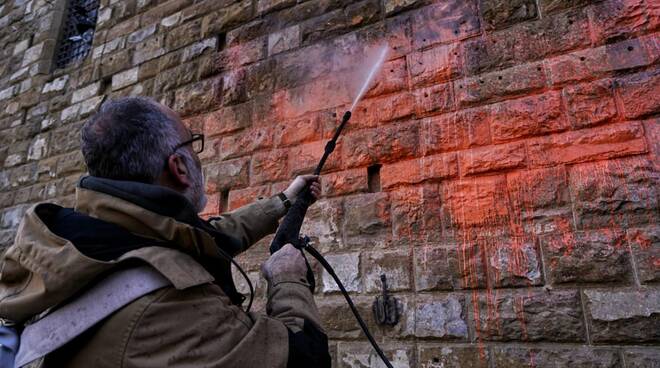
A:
<box><xmin>81</xmin><ymin>97</ymin><xmax>181</xmax><ymax>184</ymax></box>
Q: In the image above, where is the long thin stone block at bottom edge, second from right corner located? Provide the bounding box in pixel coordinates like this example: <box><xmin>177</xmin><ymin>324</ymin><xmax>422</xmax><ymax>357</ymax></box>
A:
<box><xmin>493</xmin><ymin>346</ymin><xmax>622</xmax><ymax>368</ymax></box>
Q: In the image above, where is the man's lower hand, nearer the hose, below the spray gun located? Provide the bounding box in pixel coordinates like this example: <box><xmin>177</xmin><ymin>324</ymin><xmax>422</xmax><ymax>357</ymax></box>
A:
<box><xmin>261</xmin><ymin>244</ymin><xmax>307</xmax><ymax>285</ymax></box>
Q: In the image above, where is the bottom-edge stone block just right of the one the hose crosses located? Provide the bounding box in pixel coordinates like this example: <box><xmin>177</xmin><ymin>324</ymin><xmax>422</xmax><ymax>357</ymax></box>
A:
<box><xmin>418</xmin><ymin>345</ymin><xmax>491</xmax><ymax>368</ymax></box>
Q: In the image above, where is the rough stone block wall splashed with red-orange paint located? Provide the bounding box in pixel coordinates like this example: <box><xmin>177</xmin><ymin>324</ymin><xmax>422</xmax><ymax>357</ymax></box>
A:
<box><xmin>0</xmin><ymin>0</ymin><xmax>660</xmax><ymax>367</ymax></box>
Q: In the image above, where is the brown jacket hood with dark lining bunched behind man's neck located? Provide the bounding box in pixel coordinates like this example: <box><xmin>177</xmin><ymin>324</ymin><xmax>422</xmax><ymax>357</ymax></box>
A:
<box><xmin>0</xmin><ymin>177</ymin><xmax>242</xmax><ymax>323</ymax></box>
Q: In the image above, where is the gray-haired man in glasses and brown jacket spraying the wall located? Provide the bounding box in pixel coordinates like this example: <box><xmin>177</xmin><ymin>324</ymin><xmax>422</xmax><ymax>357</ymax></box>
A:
<box><xmin>0</xmin><ymin>97</ymin><xmax>330</xmax><ymax>368</ymax></box>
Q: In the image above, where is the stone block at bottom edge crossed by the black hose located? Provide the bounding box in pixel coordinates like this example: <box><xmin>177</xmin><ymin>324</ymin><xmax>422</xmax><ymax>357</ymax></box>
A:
<box><xmin>336</xmin><ymin>342</ymin><xmax>418</xmax><ymax>368</ymax></box>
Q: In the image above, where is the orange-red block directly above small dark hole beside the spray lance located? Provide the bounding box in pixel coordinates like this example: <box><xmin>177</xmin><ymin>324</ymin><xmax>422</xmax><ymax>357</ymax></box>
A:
<box><xmin>341</xmin><ymin>123</ymin><xmax>419</xmax><ymax>167</ymax></box>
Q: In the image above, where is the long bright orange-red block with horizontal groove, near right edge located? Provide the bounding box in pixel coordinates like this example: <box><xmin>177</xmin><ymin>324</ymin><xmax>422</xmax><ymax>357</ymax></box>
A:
<box><xmin>528</xmin><ymin>122</ymin><xmax>647</xmax><ymax>167</ymax></box>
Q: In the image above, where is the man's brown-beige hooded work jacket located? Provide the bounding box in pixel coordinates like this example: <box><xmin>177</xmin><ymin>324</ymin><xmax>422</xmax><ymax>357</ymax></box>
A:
<box><xmin>0</xmin><ymin>177</ymin><xmax>320</xmax><ymax>368</ymax></box>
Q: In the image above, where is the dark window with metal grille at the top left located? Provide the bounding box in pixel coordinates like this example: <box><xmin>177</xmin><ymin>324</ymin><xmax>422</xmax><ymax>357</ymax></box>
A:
<box><xmin>55</xmin><ymin>0</ymin><xmax>99</xmax><ymax>69</ymax></box>
